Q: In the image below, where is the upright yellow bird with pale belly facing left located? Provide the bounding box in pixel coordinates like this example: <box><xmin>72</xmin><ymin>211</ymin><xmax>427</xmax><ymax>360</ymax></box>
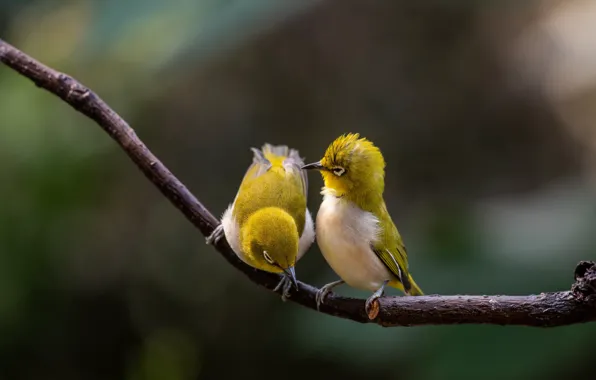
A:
<box><xmin>302</xmin><ymin>133</ymin><xmax>423</xmax><ymax>312</ymax></box>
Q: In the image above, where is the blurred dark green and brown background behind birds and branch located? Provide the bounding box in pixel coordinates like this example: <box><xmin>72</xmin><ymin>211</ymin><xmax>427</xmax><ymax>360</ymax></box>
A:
<box><xmin>0</xmin><ymin>0</ymin><xmax>596</xmax><ymax>380</ymax></box>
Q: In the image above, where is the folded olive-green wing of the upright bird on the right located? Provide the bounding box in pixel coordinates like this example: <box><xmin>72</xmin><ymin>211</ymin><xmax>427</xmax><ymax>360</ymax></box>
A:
<box><xmin>371</xmin><ymin>203</ymin><xmax>412</xmax><ymax>292</ymax></box>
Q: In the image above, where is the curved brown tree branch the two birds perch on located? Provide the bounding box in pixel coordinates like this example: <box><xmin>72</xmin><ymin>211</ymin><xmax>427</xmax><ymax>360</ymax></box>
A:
<box><xmin>0</xmin><ymin>40</ymin><xmax>596</xmax><ymax>327</ymax></box>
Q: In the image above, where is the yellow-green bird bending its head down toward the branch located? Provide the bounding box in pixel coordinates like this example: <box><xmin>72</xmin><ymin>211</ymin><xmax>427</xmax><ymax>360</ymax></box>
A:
<box><xmin>207</xmin><ymin>144</ymin><xmax>315</xmax><ymax>300</ymax></box>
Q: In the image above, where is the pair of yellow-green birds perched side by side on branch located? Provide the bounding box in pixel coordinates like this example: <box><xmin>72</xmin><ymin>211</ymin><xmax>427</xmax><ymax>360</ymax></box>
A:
<box><xmin>207</xmin><ymin>133</ymin><xmax>423</xmax><ymax>312</ymax></box>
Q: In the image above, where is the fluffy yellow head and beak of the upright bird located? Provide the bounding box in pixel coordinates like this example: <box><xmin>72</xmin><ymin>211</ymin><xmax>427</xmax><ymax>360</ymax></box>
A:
<box><xmin>303</xmin><ymin>133</ymin><xmax>385</xmax><ymax>198</ymax></box>
